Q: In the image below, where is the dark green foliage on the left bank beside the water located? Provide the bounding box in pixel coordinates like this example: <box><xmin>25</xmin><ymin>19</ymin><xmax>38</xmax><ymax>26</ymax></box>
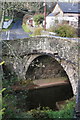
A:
<box><xmin>3</xmin><ymin>75</ymin><xmax>27</xmax><ymax>120</ymax></box>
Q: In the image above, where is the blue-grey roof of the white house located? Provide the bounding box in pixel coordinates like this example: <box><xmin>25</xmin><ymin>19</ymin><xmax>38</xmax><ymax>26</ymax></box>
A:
<box><xmin>58</xmin><ymin>2</ymin><xmax>80</xmax><ymax>13</ymax></box>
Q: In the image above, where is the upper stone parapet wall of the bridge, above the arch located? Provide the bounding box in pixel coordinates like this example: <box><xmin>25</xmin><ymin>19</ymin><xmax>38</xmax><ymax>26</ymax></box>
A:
<box><xmin>4</xmin><ymin>36</ymin><xmax>78</xmax><ymax>63</ymax></box>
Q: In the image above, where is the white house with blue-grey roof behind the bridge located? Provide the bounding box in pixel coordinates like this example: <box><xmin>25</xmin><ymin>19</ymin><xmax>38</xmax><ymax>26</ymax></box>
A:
<box><xmin>46</xmin><ymin>2</ymin><xmax>80</xmax><ymax>29</ymax></box>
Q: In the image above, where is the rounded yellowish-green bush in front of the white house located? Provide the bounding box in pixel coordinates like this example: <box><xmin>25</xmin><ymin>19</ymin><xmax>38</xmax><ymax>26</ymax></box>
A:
<box><xmin>55</xmin><ymin>25</ymin><xmax>76</xmax><ymax>37</ymax></box>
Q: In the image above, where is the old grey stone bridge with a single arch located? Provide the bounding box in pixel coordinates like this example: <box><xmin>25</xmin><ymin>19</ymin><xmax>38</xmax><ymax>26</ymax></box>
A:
<box><xmin>2</xmin><ymin>36</ymin><xmax>79</xmax><ymax>95</ymax></box>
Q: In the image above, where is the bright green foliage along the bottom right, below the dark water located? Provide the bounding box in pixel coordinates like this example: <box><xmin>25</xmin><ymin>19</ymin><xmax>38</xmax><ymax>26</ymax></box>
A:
<box><xmin>26</xmin><ymin>100</ymin><xmax>75</xmax><ymax>119</ymax></box>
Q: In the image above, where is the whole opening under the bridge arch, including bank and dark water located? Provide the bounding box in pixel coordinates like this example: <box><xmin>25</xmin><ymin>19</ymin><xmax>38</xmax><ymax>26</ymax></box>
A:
<box><xmin>25</xmin><ymin>55</ymin><xmax>73</xmax><ymax>109</ymax></box>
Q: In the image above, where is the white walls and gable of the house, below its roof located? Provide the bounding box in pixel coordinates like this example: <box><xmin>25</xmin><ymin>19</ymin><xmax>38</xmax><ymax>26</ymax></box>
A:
<box><xmin>46</xmin><ymin>4</ymin><xmax>80</xmax><ymax>28</ymax></box>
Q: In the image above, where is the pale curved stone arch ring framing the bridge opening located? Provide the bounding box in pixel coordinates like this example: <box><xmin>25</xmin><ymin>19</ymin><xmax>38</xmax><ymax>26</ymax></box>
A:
<box><xmin>25</xmin><ymin>51</ymin><xmax>77</xmax><ymax>95</ymax></box>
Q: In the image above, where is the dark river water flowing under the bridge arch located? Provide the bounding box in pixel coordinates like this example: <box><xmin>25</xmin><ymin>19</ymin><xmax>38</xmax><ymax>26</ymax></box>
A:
<box><xmin>16</xmin><ymin>78</ymin><xmax>73</xmax><ymax>110</ymax></box>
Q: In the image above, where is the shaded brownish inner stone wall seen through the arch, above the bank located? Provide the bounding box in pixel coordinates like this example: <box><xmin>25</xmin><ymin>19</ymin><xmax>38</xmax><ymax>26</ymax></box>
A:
<box><xmin>25</xmin><ymin>55</ymin><xmax>69</xmax><ymax>80</ymax></box>
